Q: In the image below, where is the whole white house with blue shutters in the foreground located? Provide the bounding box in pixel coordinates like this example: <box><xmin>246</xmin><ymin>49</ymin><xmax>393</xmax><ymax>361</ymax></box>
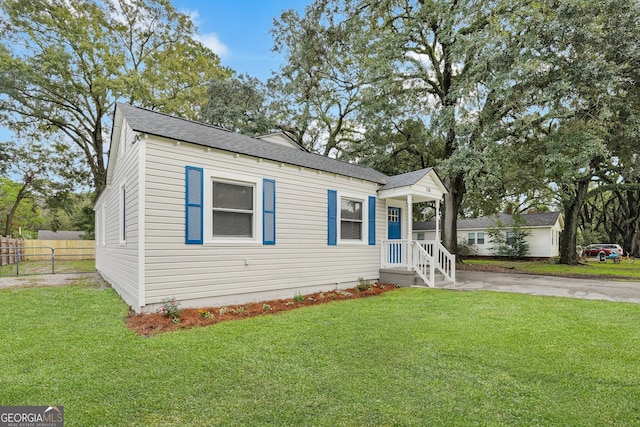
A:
<box><xmin>94</xmin><ymin>104</ymin><xmax>455</xmax><ymax>312</ymax></box>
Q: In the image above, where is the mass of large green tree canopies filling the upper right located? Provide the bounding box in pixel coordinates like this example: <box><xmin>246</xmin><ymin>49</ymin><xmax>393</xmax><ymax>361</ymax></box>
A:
<box><xmin>276</xmin><ymin>0</ymin><xmax>640</xmax><ymax>263</ymax></box>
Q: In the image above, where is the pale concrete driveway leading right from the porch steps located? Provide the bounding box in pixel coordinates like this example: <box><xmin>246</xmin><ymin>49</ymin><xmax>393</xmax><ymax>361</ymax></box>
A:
<box><xmin>442</xmin><ymin>270</ymin><xmax>640</xmax><ymax>304</ymax></box>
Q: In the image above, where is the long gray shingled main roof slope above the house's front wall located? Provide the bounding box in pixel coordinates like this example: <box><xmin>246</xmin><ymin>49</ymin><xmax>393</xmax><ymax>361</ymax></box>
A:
<box><xmin>117</xmin><ymin>103</ymin><xmax>390</xmax><ymax>184</ymax></box>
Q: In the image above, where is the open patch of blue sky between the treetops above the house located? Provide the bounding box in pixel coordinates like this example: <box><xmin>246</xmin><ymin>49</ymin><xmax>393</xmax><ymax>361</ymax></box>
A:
<box><xmin>0</xmin><ymin>0</ymin><xmax>312</xmax><ymax>141</ymax></box>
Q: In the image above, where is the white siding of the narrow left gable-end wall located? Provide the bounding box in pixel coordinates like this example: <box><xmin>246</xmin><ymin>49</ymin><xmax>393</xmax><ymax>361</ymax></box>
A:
<box><xmin>95</xmin><ymin>125</ymin><xmax>142</xmax><ymax>309</ymax></box>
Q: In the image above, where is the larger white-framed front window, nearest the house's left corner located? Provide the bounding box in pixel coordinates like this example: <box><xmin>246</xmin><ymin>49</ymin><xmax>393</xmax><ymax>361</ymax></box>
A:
<box><xmin>211</xmin><ymin>179</ymin><xmax>255</xmax><ymax>238</ymax></box>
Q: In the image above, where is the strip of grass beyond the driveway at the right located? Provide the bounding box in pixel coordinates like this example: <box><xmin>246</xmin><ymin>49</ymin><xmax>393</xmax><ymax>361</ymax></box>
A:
<box><xmin>464</xmin><ymin>259</ymin><xmax>640</xmax><ymax>281</ymax></box>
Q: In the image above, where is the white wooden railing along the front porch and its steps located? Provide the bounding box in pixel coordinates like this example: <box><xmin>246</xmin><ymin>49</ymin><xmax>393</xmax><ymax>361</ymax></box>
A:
<box><xmin>380</xmin><ymin>240</ymin><xmax>456</xmax><ymax>287</ymax></box>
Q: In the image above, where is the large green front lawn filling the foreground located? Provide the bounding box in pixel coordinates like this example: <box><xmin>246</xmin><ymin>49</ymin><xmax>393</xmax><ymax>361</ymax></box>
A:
<box><xmin>0</xmin><ymin>282</ymin><xmax>640</xmax><ymax>427</ymax></box>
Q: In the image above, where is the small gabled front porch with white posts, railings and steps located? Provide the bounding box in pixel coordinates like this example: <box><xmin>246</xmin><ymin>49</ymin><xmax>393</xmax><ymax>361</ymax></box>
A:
<box><xmin>378</xmin><ymin>168</ymin><xmax>456</xmax><ymax>287</ymax></box>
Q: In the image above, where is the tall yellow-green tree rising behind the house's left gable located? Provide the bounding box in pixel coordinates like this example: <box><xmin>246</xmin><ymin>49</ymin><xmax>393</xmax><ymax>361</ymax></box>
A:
<box><xmin>0</xmin><ymin>0</ymin><xmax>228</xmax><ymax>193</ymax></box>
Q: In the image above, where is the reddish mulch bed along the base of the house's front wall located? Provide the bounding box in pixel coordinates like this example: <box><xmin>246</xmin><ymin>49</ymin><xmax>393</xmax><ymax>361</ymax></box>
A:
<box><xmin>127</xmin><ymin>283</ymin><xmax>396</xmax><ymax>337</ymax></box>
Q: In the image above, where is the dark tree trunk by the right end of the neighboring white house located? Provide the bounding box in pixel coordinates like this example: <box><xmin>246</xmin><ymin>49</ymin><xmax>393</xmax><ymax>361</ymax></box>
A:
<box><xmin>560</xmin><ymin>179</ymin><xmax>590</xmax><ymax>264</ymax></box>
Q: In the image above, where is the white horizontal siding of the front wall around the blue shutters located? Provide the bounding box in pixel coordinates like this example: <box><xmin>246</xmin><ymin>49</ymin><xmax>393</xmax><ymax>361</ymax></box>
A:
<box><xmin>145</xmin><ymin>137</ymin><xmax>386</xmax><ymax>306</ymax></box>
